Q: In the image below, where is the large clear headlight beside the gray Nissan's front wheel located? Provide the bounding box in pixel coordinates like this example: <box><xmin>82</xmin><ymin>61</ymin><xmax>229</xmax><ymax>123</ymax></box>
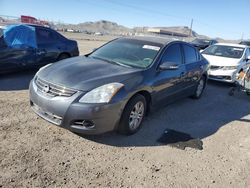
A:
<box><xmin>79</xmin><ymin>83</ymin><xmax>124</xmax><ymax>103</ymax></box>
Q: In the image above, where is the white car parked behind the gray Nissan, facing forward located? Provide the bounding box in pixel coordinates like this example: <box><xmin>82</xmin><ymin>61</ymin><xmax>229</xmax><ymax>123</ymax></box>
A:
<box><xmin>202</xmin><ymin>43</ymin><xmax>250</xmax><ymax>83</ymax></box>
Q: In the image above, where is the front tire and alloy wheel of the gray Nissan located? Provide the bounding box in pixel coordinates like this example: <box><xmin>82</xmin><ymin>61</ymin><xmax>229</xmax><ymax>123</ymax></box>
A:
<box><xmin>118</xmin><ymin>94</ymin><xmax>147</xmax><ymax>135</ymax></box>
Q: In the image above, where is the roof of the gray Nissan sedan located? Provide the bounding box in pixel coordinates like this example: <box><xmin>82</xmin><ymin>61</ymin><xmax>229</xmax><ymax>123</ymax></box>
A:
<box><xmin>124</xmin><ymin>36</ymin><xmax>176</xmax><ymax>45</ymax></box>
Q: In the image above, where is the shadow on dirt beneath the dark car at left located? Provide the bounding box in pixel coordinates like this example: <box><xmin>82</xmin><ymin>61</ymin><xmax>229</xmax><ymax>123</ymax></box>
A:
<box><xmin>0</xmin><ymin>69</ymin><xmax>37</xmax><ymax>91</ymax></box>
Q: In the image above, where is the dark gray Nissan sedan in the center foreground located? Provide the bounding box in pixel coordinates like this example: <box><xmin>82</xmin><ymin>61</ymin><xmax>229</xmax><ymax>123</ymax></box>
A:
<box><xmin>29</xmin><ymin>37</ymin><xmax>208</xmax><ymax>134</ymax></box>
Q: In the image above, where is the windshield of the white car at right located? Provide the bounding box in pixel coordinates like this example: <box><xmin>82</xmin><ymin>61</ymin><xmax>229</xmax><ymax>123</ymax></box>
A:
<box><xmin>202</xmin><ymin>45</ymin><xmax>244</xmax><ymax>59</ymax></box>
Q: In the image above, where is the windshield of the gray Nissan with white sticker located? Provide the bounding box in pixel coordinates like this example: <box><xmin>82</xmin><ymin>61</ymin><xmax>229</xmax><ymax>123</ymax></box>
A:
<box><xmin>89</xmin><ymin>39</ymin><xmax>162</xmax><ymax>68</ymax></box>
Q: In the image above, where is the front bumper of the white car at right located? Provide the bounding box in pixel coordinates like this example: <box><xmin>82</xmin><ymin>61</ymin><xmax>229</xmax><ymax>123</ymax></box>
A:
<box><xmin>208</xmin><ymin>69</ymin><xmax>236</xmax><ymax>83</ymax></box>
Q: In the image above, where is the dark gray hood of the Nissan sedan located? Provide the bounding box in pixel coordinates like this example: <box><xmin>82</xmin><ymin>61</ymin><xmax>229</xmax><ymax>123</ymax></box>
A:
<box><xmin>37</xmin><ymin>56</ymin><xmax>142</xmax><ymax>91</ymax></box>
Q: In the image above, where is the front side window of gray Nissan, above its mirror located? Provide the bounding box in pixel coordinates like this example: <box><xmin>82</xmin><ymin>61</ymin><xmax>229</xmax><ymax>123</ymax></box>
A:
<box><xmin>162</xmin><ymin>44</ymin><xmax>182</xmax><ymax>65</ymax></box>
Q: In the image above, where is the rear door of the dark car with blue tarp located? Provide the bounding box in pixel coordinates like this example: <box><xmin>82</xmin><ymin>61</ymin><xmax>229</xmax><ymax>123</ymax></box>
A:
<box><xmin>36</xmin><ymin>27</ymin><xmax>61</xmax><ymax>65</ymax></box>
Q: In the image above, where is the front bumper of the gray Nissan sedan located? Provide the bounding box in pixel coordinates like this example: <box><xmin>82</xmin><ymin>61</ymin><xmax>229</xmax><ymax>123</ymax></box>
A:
<box><xmin>29</xmin><ymin>80</ymin><xmax>125</xmax><ymax>134</ymax></box>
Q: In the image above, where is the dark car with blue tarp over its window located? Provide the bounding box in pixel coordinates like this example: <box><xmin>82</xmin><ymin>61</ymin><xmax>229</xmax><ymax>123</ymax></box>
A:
<box><xmin>0</xmin><ymin>24</ymin><xmax>79</xmax><ymax>73</ymax></box>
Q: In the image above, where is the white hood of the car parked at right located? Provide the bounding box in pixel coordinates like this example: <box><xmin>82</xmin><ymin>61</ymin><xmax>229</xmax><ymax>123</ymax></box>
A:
<box><xmin>202</xmin><ymin>54</ymin><xmax>240</xmax><ymax>66</ymax></box>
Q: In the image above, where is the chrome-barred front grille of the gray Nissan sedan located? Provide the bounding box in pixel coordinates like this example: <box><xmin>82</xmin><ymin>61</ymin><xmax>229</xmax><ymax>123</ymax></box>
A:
<box><xmin>35</xmin><ymin>77</ymin><xmax>77</xmax><ymax>97</ymax></box>
